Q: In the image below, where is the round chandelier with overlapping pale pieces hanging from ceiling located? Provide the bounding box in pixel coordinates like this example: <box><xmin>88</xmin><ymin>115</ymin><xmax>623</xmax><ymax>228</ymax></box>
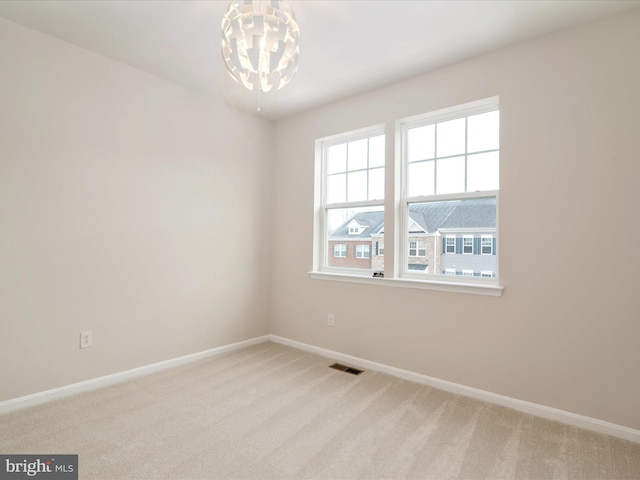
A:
<box><xmin>222</xmin><ymin>0</ymin><xmax>300</xmax><ymax>106</ymax></box>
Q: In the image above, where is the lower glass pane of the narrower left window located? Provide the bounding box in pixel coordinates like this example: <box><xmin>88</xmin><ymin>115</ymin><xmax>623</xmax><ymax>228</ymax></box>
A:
<box><xmin>325</xmin><ymin>205</ymin><xmax>384</xmax><ymax>271</ymax></box>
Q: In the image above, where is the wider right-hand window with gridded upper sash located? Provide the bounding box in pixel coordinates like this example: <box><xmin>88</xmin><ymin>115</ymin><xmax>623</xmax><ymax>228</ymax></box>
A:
<box><xmin>398</xmin><ymin>98</ymin><xmax>500</xmax><ymax>279</ymax></box>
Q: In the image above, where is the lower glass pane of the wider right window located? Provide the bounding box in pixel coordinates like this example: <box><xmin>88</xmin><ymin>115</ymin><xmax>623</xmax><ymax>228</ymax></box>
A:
<box><xmin>405</xmin><ymin>197</ymin><xmax>497</xmax><ymax>276</ymax></box>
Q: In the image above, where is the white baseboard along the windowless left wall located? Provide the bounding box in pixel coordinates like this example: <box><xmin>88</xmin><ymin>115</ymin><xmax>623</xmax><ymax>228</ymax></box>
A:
<box><xmin>0</xmin><ymin>335</ymin><xmax>269</xmax><ymax>415</ymax></box>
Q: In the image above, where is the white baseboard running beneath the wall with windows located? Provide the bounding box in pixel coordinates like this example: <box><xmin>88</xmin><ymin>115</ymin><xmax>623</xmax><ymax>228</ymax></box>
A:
<box><xmin>269</xmin><ymin>335</ymin><xmax>640</xmax><ymax>443</ymax></box>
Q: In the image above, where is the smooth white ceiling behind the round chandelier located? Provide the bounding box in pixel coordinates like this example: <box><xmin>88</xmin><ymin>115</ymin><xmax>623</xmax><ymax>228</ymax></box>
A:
<box><xmin>0</xmin><ymin>0</ymin><xmax>640</xmax><ymax>118</ymax></box>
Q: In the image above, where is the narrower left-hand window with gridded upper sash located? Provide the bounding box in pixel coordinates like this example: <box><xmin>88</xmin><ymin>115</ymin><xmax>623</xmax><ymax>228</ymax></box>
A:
<box><xmin>314</xmin><ymin>126</ymin><xmax>385</xmax><ymax>270</ymax></box>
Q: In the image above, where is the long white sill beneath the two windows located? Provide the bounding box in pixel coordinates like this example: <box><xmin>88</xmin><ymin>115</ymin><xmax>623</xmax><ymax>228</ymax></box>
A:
<box><xmin>309</xmin><ymin>272</ymin><xmax>504</xmax><ymax>297</ymax></box>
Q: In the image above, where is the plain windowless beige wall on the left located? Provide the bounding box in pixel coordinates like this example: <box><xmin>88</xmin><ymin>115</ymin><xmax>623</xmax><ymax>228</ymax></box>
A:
<box><xmin>0</xmin><ymin>19</ymin><xmax>272</xmax><ymax>401</ymax></box>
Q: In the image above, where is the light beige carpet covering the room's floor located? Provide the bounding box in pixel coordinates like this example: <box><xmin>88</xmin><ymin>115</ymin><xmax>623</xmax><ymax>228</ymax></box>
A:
<box><xmin>0</xmin><ymin>342</ymin><xmax>640</xmax><ymax>480</ymax></box>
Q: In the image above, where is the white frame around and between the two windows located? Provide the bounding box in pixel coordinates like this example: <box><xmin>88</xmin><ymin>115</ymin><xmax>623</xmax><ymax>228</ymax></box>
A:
<box><xmin>310</xmin><ymin>97</ymin><xmax>504</xmax><ymax>296</ymax></box>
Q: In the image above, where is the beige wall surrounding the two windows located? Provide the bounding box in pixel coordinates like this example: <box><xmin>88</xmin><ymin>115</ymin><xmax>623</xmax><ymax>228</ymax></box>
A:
<box><xmin>271</xmin><ymin>10</ymin><xmax>640</xmax><ymax>429</ymax></box>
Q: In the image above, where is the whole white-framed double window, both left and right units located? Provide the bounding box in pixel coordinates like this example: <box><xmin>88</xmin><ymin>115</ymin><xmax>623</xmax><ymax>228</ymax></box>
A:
<box><xmin>312</xmin><ymin>97</ymin><xmax>501</xmax><ymax>294</ymax></box>
